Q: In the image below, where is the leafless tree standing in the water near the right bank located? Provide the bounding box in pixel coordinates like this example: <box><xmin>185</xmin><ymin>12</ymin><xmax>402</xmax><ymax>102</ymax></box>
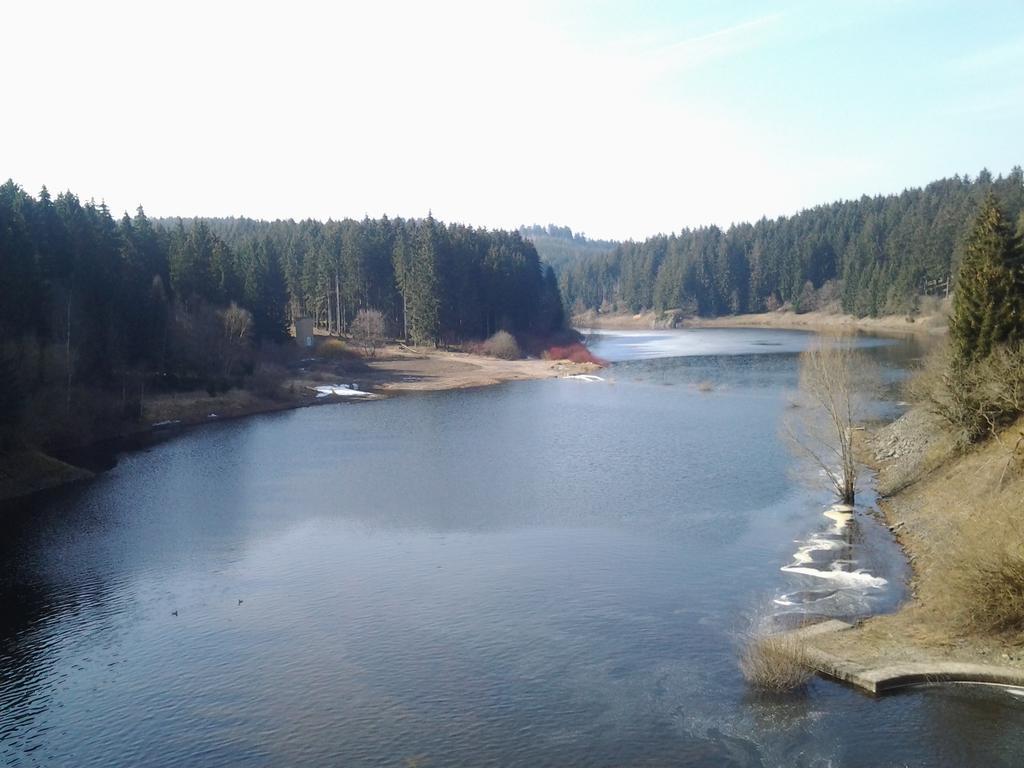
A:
<box><xmin>785</xmin><ymin>337</ymin><xmax>874</xmax><ymax>504</ymax></box>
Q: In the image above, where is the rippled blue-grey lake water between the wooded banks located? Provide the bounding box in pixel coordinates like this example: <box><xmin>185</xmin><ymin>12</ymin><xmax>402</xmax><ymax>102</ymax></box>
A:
<box><xmin>0</xmin><ymin>330</ymin><xmax>1024</xmax><ymax>768</ymax></box>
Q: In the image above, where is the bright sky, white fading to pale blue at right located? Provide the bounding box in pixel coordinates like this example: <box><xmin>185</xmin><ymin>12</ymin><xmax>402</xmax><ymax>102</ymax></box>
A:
<box><xmin>0</xmin><ymin>0</ymin><xmax>1024</xmax><ymax>239</ymax></box>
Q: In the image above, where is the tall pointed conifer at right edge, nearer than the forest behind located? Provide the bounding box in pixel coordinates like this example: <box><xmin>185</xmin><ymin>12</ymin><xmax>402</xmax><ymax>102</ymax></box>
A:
<box><xmin>949</xmin><ymin>194</ymin><xmax>1024</xmax><ymax>364</ymax></box>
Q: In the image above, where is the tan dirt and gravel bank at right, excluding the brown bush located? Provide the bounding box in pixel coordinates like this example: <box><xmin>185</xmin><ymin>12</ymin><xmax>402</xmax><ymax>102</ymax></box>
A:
<box><xmin>809</xmin><ymin>409</ymin><xmax>1024</xmax><ymax>670</ymax></box>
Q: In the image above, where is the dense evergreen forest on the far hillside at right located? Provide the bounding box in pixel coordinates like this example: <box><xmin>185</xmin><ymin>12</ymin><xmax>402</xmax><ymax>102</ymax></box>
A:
<box><xmin>559</xmin><ymin>167</ymin><xmax>1024</xmax><ymax>316</ymax></box>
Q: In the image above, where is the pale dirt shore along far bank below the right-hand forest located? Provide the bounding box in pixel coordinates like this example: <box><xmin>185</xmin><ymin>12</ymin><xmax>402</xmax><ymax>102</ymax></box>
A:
<box><xmin>572</xmin><ymin>311</ymin><xmax>946</xmax><ymax>335</ymax></box>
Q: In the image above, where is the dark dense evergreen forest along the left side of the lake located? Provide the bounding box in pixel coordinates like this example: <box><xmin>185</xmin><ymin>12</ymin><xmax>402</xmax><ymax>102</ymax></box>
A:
<box><xmin>0</xmin><ymin>181</ymin><xmax>564</xmax><ymax>450</ymax></box>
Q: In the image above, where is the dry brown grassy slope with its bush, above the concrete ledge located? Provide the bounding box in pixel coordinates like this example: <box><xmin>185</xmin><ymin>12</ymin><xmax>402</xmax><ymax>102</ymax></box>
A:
<box><xmin>808</xmin><ymin>412</ymin><xmax>1024</xmax><ymax>668</ymax></box>
